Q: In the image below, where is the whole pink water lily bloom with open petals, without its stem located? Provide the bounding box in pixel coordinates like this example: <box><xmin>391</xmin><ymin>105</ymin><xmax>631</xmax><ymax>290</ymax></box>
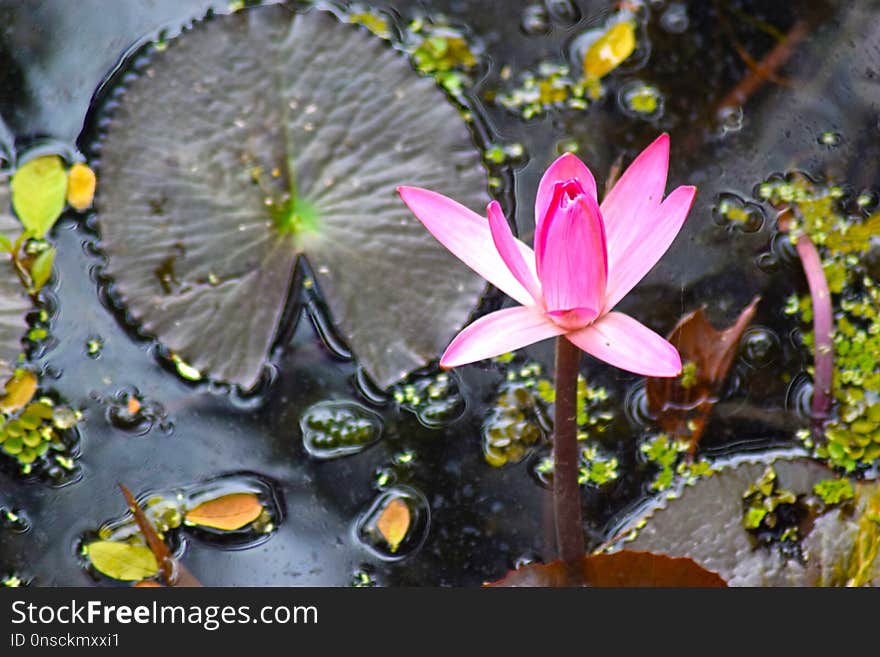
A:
<box><xmin>398</xmin><ymin>134</ymin><xmax>697</xmax><ymax>376</ymax></box>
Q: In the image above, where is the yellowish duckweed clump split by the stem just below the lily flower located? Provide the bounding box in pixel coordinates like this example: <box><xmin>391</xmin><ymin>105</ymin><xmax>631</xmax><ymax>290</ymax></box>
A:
<box><xmin>482</xmin><ymin>362</ymin><xmax>613</xmax><ymax>467</ymax></box>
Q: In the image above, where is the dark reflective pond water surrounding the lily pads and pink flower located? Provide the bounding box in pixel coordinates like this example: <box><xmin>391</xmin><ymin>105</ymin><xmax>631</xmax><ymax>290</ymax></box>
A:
<box><xmin>0</xmin><ymin>0</ymin><xmax>880</xmax><ymax>585</ymax></box>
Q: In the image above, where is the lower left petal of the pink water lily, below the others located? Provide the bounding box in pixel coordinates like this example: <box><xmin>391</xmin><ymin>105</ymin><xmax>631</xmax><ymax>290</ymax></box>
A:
<box><xmin>440</xmin><ymin>306</ymin><xmax>565</xmax><ymax>369</ymax></box>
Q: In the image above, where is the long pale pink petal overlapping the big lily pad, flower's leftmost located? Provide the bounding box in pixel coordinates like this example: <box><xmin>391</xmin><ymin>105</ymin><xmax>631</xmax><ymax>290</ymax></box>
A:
<box><xmin>397</xmin><ymin>187</ymin><xmax>535</xmax><ymax>304</ymax></box>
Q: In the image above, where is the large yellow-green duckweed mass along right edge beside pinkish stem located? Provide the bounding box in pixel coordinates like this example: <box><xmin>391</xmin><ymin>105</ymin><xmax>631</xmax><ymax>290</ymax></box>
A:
<box><xmin>757</xmin><ymin>173</ymin><xmax>880</xmax><ymax>472</ymax></box>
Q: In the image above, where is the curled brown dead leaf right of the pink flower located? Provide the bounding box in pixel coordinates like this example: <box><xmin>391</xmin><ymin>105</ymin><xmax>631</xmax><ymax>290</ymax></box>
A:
<box><xmin>645</xmin><ymin>297</ymin><xmax>761</xmax><ymax>453</ymax></box>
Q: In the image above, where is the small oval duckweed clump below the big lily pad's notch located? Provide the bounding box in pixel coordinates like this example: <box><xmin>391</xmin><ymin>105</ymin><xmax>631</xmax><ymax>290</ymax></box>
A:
<box><xmin>299</xmin><ymin>401</ymin><xmax>382</xmax><ymax>459</ymax></box>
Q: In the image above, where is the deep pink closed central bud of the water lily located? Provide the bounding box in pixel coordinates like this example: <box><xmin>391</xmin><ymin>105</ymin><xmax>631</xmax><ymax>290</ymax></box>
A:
<box><xmin>535</xmin><ymin>183</ymin><xmax>608</xmax><ymax>323</ymax></box>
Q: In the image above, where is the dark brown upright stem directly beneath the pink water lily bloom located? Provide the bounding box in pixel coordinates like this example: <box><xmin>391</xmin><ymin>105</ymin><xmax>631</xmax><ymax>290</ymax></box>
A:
<box><xmin>553</xmin><ymin>336</ymin><xmax>584</xmax><ymax>563</ymax></box>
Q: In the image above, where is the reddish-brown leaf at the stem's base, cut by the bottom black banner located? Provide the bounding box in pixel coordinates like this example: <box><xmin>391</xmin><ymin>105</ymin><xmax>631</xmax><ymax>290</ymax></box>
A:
<box><xmin>486</xmin><ymin>550</ymin><xmax>727</xmax><ymax>587</ymax></box>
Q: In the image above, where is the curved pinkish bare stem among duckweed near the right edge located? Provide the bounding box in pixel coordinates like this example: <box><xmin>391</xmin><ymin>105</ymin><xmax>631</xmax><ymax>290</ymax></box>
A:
<box><xmin>796</xmin><ymin>235</ymin><xmax>834</xmax><ymax>431</ymax></box>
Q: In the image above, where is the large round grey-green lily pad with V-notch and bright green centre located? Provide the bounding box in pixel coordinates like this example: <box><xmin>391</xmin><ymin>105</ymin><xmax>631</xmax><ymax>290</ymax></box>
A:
<box><xmin>96</xmin><ymin>6</ymin><xmax>488</xmax><ymax>388</ymax></box>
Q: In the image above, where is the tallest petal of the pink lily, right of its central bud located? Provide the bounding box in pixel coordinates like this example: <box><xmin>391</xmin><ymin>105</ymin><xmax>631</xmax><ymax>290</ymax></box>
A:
<box><xmin>602</xmin><ymin>133</ymin><xmax>669</xmax><ymax>269</ymax></box>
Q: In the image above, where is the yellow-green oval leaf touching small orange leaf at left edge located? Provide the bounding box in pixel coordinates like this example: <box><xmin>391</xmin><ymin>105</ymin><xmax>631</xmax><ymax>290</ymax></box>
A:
<box><xmin>12</xmin><ymin>155</ymin><xmax>67</xmax><ymax>238</ymax></box>
